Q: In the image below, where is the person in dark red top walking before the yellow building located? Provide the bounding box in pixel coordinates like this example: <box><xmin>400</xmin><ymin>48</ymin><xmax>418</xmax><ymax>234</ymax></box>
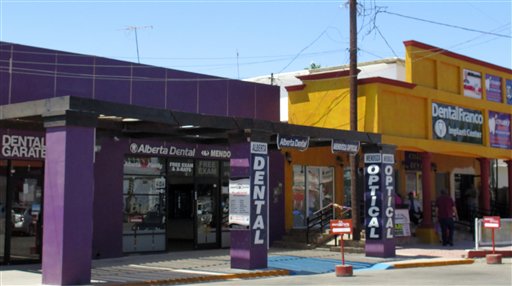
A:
<box><xmin>436</xmin><ymin>190</ymin><xmax>458</xmax><ymax>246</ymax></box>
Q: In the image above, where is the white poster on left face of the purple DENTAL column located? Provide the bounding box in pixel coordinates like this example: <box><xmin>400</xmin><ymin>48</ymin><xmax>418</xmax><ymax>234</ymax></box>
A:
<box><xmin>228</xmin><ymin>178</ymin><xmax>251</xmax><ymax>226</ymax></box>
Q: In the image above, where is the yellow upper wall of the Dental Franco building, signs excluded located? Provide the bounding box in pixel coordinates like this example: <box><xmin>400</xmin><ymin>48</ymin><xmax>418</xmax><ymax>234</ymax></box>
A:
<box><xmin>289</xmin><ymin>46</ymin><xmax>512</xmax><ymax>160</ymax></box>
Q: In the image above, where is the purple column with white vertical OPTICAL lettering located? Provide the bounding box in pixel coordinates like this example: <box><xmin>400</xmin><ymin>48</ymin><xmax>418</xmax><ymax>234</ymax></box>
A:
<box><xmin>363</xmin><ymin>145</ymin><xmax>396</xmax><ymax>257</ymax></box>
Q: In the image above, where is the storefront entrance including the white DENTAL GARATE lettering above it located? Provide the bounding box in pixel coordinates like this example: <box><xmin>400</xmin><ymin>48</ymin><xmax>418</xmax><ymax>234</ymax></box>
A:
<box><xmin>0</xmin><ymin>130</ymin><xmax>44</xmax><ymax>265</ymax></box>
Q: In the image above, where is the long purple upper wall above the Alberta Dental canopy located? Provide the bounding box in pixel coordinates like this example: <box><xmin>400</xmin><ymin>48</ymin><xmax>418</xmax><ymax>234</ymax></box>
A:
<box><xmin>0</xmin><ymin>42</ymin><xmax>279</xmax><ymax>121</ymax></box>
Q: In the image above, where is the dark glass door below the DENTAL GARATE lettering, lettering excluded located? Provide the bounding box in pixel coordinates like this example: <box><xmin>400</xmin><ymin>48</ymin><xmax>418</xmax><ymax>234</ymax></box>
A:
<box><xmin>0</xmin><ymin>160</ymin><xmax>44</xmax><ymax>264</ymax></box>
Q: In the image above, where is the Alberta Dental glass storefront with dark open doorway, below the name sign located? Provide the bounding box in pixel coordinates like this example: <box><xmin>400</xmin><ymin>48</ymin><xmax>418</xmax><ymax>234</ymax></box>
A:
<box><xmin>123</xmin><ymin>156</ymin><xmax>230</xmax><ymax>253</ymax></box>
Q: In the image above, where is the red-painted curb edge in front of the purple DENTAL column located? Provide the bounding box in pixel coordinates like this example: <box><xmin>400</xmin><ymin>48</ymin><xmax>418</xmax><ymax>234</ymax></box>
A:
<box><xmin>117</xmin><ymin>269</ymin><xmax>290</xmax><ymax>286</ymax></box>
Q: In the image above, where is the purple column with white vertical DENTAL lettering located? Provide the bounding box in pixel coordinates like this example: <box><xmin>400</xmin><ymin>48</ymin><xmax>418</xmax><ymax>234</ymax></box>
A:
<box><xmin>230</xmin><ymin>142</ymin><xmax>269</xmax><ymax>269</ymax></box>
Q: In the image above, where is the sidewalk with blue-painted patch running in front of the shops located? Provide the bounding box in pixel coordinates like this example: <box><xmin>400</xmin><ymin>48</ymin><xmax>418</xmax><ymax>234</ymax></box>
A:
<box><xmin>0</xmin><ymin>241</ymin><xmax>512</xmax><ymax>285</ymax></box>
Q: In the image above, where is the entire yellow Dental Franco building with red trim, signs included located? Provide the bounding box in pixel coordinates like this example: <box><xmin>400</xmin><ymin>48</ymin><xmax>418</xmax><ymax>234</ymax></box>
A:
<box><xmin>286</xmin><ymin>41</ymin><xmax>512</xmax><ymax>242</ymax></box>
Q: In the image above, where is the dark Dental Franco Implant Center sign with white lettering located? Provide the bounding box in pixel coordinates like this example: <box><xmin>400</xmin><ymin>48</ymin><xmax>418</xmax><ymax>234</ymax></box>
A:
<box><xmin>432</xmin><ymin>102</ymin><xmax>484</xmax><ymax>144</ymax></box>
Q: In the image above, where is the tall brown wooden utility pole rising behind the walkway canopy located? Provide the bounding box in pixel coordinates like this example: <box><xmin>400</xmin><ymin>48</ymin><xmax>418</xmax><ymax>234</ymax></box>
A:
<box><xmin>349</xmin><ymin>0</ymin><xmax>361</xmax><ymax>240</ymax></box>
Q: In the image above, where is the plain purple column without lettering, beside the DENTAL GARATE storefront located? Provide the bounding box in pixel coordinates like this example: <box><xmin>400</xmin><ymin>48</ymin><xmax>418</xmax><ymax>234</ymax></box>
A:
<box><xmin>42</xmin><ymin>126</ymin><xmax>95</xmax><ymax>285</ymax></box>
